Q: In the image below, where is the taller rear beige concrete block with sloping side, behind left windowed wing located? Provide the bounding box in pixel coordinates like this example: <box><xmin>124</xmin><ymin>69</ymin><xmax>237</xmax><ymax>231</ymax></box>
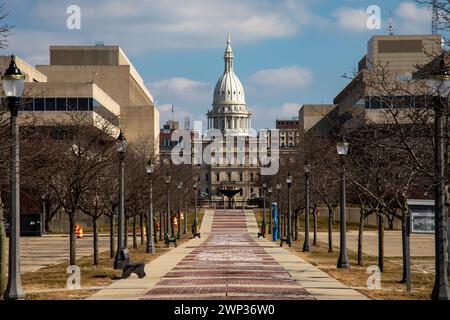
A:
<box><xmin>36</xmin><ymin>45</ymin><xmax>159</xmax><ymax>146</ymax></box>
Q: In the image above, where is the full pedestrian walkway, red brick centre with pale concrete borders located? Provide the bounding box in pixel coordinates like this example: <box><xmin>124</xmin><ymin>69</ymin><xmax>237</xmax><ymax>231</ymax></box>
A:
<box><xmin>87</xmin><ymin>210</ymin><xmax>365</xmax><ymax>300</ymax></box>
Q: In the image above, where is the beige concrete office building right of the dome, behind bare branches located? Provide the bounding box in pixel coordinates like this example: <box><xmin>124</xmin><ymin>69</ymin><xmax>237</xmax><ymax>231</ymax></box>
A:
<box><xmin>299</xmin><ymin>35</ymin><xmax>443</xmax><ymax>134</ymax></box>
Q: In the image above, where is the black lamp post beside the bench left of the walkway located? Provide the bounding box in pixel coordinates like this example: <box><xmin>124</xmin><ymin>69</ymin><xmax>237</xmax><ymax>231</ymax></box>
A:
<box><xmin>114</xmin><ymin>130</ymin><xmax>128</xmax><ymax>269</ymax></box>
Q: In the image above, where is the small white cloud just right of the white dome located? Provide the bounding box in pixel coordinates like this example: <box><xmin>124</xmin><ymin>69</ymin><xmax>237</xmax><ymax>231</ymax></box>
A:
<box><xmin>249</xmin><ymin>66</ymin><xmax>314</xmax><ymax>93</ymax></box>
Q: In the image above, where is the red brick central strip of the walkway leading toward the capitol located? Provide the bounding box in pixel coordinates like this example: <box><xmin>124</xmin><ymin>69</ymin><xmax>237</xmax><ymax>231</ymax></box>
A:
<box><xmin>144</xmin><ymin>211</ymin><xmax>313</xmax><ymax>300</ymax></box>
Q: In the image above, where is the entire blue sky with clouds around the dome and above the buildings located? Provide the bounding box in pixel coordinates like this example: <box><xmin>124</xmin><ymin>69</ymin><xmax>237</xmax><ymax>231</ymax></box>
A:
<box><xmin>3</xmin><ymin>0</ymin><xmax>442</xmax><ymax>128</ymax></box>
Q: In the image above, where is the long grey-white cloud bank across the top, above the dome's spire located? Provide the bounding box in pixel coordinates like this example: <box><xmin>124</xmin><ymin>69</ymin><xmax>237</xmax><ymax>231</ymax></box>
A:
<box><xmin>8</xmin><ymin>0</ymin><xmax>321</xmax><ymax>57</ymax></box>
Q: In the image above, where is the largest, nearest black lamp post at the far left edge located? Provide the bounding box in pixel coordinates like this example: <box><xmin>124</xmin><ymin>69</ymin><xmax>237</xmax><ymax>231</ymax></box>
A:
<box><xmin>2</xmin><ymin>56</ymin><xmax>25</xmax><ymax>299</ymax></box>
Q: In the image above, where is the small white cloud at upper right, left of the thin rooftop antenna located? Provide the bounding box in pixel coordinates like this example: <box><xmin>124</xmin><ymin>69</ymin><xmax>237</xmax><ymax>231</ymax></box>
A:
<box><xmin>333</xmin><ymin>7</ymin><xmax>368</xmax><ymax>32</ymax></box>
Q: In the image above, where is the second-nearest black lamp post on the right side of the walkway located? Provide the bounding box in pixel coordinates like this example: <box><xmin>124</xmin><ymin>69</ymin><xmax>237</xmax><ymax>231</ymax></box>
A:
<box><xmin>336</xmin><ymin>140</ymin><xmax>350</xmax><ymax>269</ymax></box>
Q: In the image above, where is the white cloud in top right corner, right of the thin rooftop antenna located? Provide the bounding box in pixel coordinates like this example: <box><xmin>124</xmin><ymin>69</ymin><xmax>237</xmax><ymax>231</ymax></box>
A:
<box><xmin>394</xmin><ymin>2</ymin><xmax>431</xmax><ymax>34</ymax></box>
